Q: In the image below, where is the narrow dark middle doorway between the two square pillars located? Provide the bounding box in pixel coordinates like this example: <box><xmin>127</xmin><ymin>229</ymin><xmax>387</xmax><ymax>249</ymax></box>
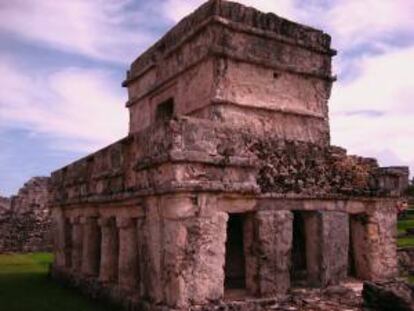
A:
<box><xmin>290</xmin><ymin>212</ymin><xmax>307</xmax><ymax>285</ymax></box>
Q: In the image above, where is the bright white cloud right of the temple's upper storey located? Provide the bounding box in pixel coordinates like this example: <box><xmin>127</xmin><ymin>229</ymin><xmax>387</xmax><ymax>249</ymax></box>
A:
<box><xmin>330</xmin><ymin>47</ymin><xmax>414</xmax><ymax>172</ymax></box>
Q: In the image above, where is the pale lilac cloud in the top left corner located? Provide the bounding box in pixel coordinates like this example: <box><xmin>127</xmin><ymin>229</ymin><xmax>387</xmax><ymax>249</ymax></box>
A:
<box><xmin>0</xmin><ymin>0</ymin><xmax>152</xmax><ymax>63</ymax></box>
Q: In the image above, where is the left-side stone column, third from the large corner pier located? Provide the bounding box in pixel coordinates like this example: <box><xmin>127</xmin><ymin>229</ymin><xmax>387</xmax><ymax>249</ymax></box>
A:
<box><xmin>81</xmin><ymin>217</ymin><xmax>101</xmax><ymax>276</ymax></box>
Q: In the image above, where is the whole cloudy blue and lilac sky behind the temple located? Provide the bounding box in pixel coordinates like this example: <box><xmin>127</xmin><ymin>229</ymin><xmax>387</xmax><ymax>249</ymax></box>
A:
<box><xmin>0</xmin><ymin>0</ymin><xmax>414</xmax><ymax>196</ymax></box>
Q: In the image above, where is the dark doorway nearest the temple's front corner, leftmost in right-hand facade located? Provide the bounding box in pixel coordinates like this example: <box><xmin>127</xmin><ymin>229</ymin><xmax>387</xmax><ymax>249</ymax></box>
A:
<box><xmin>224</xmin><ymin>214</ymin><xmax>246</xmax><ymax>289</ymax></box>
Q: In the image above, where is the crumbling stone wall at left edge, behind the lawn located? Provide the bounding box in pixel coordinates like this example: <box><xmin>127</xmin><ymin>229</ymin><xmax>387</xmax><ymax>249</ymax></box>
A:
<box><xmin>0</xmin><ymin>177</ymin><xmax>51</xmax><ymax>253</ymax></box>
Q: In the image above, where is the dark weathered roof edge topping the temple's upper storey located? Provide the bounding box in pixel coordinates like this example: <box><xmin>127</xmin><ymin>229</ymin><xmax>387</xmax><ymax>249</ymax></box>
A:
<box><xmin>127</xmin><ymin>0</ymin><xmax>336</xmax><ymax>84</ymax></box>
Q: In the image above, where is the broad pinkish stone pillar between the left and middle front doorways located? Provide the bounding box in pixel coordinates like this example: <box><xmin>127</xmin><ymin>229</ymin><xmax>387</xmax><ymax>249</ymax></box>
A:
<box><xmin>256</xmin><ymin>211</ymin><xmax>293</xmax><ymax>297</ymax></box>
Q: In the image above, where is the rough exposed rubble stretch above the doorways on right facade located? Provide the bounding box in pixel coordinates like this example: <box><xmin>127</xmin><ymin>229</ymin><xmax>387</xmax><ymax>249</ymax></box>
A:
<box><xmin>252</xmin><ymin>139</ymin><xmax>379</xmax><ymax>195</ymax></box>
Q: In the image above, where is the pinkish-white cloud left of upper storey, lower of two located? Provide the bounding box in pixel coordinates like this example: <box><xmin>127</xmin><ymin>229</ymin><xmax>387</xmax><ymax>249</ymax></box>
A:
<box><xmin>0</xmin><ymin>58</ymin><xmax>128</xmax><ymax>152</ymax></box>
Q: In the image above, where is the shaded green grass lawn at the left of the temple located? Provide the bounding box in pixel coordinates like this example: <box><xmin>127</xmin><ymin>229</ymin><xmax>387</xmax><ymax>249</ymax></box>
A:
<box><xmin>0</xmin><ymin>253</ymin><xmax>119</xmax><ymax>311</ymax></box>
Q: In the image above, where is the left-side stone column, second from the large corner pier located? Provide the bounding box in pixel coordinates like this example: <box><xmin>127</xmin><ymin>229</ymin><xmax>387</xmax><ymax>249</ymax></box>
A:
<box><xmin>98</xmin><ymin>217</ymin><xmax>119</xmax><ymax>282</ymax></box>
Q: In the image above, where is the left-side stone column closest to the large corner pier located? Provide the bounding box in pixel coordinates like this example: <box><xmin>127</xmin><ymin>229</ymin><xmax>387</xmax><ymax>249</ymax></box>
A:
<box><xmin>116</xmin><ymin>218</ymin><xmax>139</xmax><ymax>290</ymax></box>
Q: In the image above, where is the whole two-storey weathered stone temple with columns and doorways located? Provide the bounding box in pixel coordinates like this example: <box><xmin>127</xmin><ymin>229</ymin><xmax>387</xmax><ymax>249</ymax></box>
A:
<box><xmin>51</xmin><ymin>0</ymin><xmax>407</xmax><ymax>310</ymax></box>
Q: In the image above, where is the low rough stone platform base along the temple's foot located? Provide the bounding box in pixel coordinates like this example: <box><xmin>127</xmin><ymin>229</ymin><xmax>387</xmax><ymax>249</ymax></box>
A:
<box><xmin>51</xmin><ymin>267</ymin><xmax>363</xmax><ymax>311</ymax></box>
